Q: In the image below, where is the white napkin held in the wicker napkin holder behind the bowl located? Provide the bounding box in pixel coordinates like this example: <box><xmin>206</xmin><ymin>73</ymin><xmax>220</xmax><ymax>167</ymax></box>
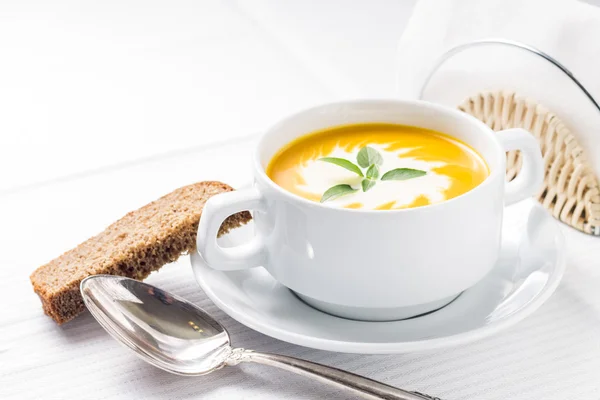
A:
<box><xmin>397</xmin><ymin>0</ymin><xmax>600</xmax><ymax>176</ymax></box>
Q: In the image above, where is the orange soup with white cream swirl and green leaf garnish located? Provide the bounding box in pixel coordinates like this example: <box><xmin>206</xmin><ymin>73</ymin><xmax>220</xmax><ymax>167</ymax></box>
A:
<box><xmin>267</xmin><ymin>123</ymin><xmax>489</xmax><ymax>210</ymax></box>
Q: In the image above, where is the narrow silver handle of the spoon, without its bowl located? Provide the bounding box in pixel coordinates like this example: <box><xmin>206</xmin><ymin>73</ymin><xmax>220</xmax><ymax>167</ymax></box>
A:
<box><xmin>227</xmin><ymin>349</ymin><xmax>441</xmax><ymax>400</ymax></box>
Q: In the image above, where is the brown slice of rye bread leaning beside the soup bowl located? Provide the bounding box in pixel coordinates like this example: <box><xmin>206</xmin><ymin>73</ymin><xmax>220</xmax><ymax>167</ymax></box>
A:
<box><xmin>31</xmin><ymin>182</ymin><xmax>251</xmax><ymax>324</ymax></box>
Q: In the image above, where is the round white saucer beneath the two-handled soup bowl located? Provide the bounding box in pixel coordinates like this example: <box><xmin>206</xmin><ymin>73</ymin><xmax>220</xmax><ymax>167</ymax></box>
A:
<box><xmin>191</xmin><ymin>205</ymin><xmax>565</xmax><ymax>354</ymax></box>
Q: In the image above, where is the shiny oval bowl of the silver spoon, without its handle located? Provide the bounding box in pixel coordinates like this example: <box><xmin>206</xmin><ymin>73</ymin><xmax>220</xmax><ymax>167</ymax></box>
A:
<box><xmin>81</xmin><ymin>275</ymin><xmax>231</xmax><ymax>375</ymax></box>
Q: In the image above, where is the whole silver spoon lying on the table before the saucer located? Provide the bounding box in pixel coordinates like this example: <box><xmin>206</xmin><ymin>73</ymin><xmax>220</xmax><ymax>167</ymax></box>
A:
<box><xmin>81</xmin><ymin>275</ymin><xmax>439</xmax><ymax>400</ymax></box>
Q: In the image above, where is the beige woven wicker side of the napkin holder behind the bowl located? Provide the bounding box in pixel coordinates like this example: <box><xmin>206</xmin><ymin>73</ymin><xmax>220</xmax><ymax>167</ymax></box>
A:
<box><xmin>459</xmin><ymin>92</ymin><xmax>600</xmax><ymax>235</ymax></box>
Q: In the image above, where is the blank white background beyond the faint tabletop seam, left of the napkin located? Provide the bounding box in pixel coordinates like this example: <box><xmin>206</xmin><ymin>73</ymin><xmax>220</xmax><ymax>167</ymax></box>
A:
<box><xmin>0</xmin><ymin>0</ymin><xmax>414</xmax><ymax>193</ymax></box>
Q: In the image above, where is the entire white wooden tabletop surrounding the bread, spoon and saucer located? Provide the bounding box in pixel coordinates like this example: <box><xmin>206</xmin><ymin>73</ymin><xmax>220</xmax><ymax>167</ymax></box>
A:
<box><xmin>0</xmin><ymin>0</ymin><xmax>600</xmax><ymax>400</ymax></box>
